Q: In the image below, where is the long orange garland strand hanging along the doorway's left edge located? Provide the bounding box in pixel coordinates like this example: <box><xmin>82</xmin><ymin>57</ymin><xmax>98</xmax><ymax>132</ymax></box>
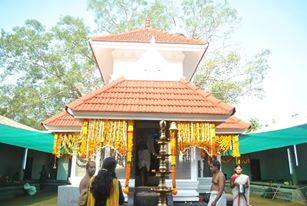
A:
<box><xmin>123</xmin><ymin>121</ymin><xmax>133</xmax><ymax>194</ymax></box>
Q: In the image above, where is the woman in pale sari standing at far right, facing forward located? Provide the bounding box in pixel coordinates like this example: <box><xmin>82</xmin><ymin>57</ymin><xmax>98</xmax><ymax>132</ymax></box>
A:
<box><xmin>230</xmin><ymin>165</ymin><xmax>250</xmax><ymax>206</ymax></box>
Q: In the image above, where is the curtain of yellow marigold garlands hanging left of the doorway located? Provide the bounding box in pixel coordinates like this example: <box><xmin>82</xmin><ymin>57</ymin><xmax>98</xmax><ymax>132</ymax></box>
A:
<box><xmin>53</xmin><ymin>120</ymin><xmax>127</xmax><ymax>159</ymax></box>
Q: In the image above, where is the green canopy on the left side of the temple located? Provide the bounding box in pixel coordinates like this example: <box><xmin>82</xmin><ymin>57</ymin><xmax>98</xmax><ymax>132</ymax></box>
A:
<box><xmin>0</xmin><ymin>124</ymin><xmax>53</xmax><ymax>153</ymax></box>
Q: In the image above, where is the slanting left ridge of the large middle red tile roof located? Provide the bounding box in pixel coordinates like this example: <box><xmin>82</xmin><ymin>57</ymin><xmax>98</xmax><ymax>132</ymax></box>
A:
<box><xmin>65</xmin><ymin>78</ymin><xmax>125</xmax><ymax>113</ymax></box>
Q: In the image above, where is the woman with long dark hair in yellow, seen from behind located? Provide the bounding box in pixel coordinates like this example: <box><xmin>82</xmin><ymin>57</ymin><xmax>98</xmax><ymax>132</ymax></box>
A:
<box><xmin>87</xmin><ymin>157</ymin><xmax>125</xmax><ymax>206</ymax></box>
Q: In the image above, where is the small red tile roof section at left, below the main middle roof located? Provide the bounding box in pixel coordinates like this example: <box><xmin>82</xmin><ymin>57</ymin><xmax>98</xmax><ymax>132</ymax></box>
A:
<box><xmin>42</xmin><ymin>111</ymin><xmax>81</xmax><ymax>127</ymax></box>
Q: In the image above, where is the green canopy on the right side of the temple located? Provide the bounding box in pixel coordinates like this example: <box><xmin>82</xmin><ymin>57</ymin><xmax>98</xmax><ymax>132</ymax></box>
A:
<box><xmin>239</xmin><ymin>124</ymin><xmax>307</xmax><ymax>154</ymax></box>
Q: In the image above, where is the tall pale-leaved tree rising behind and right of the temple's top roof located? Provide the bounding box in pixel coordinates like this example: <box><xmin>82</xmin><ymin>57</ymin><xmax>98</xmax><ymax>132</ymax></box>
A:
<box><xmin>88</xmin><ymin>0</ymin><xmax>270</xmax><ymax>103</ymax></box>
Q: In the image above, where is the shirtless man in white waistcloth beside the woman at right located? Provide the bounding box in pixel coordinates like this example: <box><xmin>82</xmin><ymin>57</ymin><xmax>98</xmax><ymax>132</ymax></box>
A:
<box><xmin>208</xmin><ymin>160</ymin><xmax>227</xmax><ymax>206</ymax></box>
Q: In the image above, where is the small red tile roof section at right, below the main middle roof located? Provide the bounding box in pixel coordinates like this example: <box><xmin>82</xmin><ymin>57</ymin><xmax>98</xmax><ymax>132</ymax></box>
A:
<box><xmin>216</xmin><ymin>116</ymin><xmax>250</xmax><ymax>133</ymax></box>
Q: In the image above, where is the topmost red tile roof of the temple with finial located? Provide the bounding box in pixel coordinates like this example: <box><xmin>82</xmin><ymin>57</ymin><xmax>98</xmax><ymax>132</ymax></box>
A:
<box><xmin>91</xmin><ymin>28</ymin><xmax>207</xmax><ymax>45</ymax></box>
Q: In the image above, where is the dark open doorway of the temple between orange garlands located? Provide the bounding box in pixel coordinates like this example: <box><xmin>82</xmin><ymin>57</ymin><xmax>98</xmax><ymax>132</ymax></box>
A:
<box><xmin>133</xmin><ymin>121</ymin><xmax>160</xmax><ymax>187</ymax></box>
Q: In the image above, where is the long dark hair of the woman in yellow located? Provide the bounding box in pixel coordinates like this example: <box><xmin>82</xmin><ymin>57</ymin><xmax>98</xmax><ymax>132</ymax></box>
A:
<box><xmin>91</xmin><ymin>157</ymin><xmax>117</xmax><ymax>202</ymax></box>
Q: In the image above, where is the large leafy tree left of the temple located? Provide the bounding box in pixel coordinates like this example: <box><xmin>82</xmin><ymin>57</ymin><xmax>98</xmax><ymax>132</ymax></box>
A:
<box><xmin>0</xmin><ymin>16</ymin><xmax>98</xmax><ymax>128</ymax></box>
